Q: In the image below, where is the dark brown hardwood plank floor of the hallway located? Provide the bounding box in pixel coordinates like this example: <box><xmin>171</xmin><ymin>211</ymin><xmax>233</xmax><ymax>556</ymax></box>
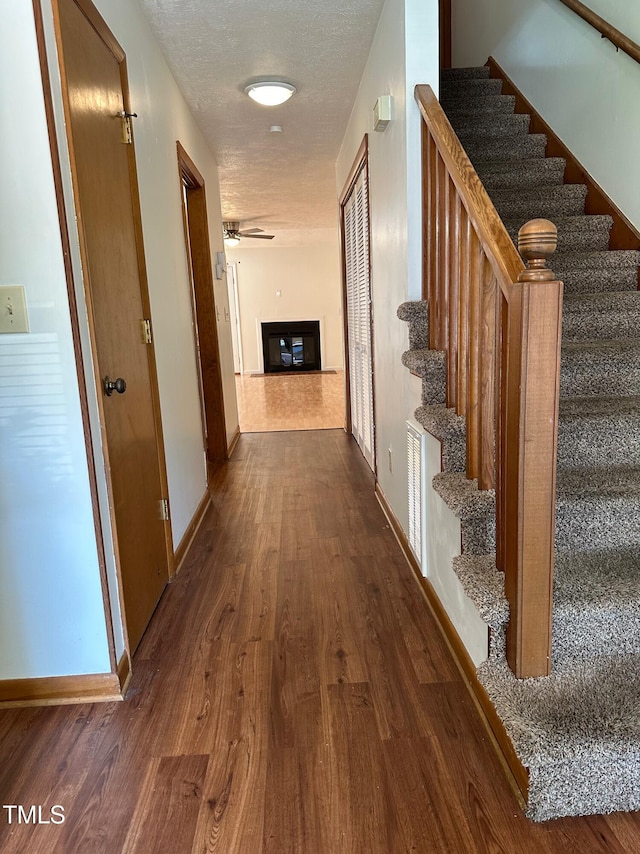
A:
<box><xmin>0</xmin><ymin>430</ymin><xmax>640</xmax><ymax>854</ymax></box>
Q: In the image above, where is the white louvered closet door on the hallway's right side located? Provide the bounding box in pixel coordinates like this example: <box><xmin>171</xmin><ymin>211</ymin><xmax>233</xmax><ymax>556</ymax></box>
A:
<box><xmin>343</xmin><ymin>164</ymin><xmax>375</xmax><ymax>469</ymax></box>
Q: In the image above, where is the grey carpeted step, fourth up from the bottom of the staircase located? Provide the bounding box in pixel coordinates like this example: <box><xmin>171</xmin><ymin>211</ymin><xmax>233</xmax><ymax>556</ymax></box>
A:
<box><xmin>557</xmin><ymin>396</ymin><xmax>640</xmax><ymax>469</ymax></box>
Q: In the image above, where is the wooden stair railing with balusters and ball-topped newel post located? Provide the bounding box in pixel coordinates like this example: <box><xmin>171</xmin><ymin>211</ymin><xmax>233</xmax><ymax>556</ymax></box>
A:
<box><xmin>416</xmin><ymin>86</ymin><xmax>562</xmax><ymax>677</ymax></box>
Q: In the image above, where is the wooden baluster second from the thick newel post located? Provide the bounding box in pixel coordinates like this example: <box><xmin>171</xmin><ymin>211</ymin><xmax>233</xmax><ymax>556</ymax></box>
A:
<box><xmin>478</xmin><ymin>255</ymin><xmax>496</xmax><ymax>489</ymax></box>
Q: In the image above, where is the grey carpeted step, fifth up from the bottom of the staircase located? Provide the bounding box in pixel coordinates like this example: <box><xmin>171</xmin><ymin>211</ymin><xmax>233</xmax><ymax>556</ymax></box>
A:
<box><xmin>560</xmin><ymin>338</ymin><xmax>640</xmax><ymax>397</ymax></box>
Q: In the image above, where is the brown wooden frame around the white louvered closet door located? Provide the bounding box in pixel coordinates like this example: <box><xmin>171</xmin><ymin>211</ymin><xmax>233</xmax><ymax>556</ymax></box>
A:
<box><xmin>338</xmin><ymin>133</ymin><xmax>378</xmax><ymax>478</ymax></box>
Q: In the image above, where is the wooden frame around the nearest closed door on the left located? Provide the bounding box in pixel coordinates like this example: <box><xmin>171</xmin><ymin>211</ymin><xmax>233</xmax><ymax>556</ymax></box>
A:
<box><xmin>48</xmin><ymin>0</ymin><xmax>175</xmax><ymax>656</ymax></box>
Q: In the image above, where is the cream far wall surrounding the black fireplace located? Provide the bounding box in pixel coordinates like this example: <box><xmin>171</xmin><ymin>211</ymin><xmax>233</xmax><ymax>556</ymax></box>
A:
<box><xmin>227</xmin><ymin>241</ymin><xmax>343</xmax><ymax>373</ymax></box>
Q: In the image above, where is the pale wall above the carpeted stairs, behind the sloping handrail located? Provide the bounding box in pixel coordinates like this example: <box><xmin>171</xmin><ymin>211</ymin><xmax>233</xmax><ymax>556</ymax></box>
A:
<box><xmin>453</xmin><ymin>0</ymin><xmax>640</xmax><ymax>228</ymax></box>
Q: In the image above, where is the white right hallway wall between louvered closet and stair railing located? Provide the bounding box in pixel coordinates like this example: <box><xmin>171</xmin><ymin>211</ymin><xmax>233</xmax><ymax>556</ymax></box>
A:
<box><xmin>336</xmin><ymin>0</ymin><xmax>439</xmax><ymax>530</ymax></box>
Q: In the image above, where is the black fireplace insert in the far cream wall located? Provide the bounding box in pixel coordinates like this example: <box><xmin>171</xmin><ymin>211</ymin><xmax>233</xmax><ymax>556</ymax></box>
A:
<box><xmin>262</xmin><ymin>320</ymin><xmax>321</xmax><ymax>374</ymax></box>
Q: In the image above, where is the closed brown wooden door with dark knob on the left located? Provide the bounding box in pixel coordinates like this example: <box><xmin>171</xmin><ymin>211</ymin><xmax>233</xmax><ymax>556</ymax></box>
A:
<box><xmin>55</xmin><ymin>0</ymin><xmax>172</xmax><ymax>651</ymax></box>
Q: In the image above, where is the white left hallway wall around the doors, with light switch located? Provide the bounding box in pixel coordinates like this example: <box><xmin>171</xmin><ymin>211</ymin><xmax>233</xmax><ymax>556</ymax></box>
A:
<box><xmin>0</xmin><ymin>0</ymin><xmax>238</xmax><ymax>679</ymax></box>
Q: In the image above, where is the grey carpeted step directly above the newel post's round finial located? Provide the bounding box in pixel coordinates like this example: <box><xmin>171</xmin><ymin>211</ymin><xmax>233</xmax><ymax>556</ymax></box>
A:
<box><xmin>491</xmin><ymin>184</ymin><xmax>587</xmax><ymax>224</ymax></box>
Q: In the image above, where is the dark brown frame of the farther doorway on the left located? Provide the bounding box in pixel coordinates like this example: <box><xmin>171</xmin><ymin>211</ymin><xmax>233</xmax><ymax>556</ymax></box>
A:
<box><xmin>176</xmin><ymin>141</ymin><xmax>229</xmax><ymax>466</ymax></box>
